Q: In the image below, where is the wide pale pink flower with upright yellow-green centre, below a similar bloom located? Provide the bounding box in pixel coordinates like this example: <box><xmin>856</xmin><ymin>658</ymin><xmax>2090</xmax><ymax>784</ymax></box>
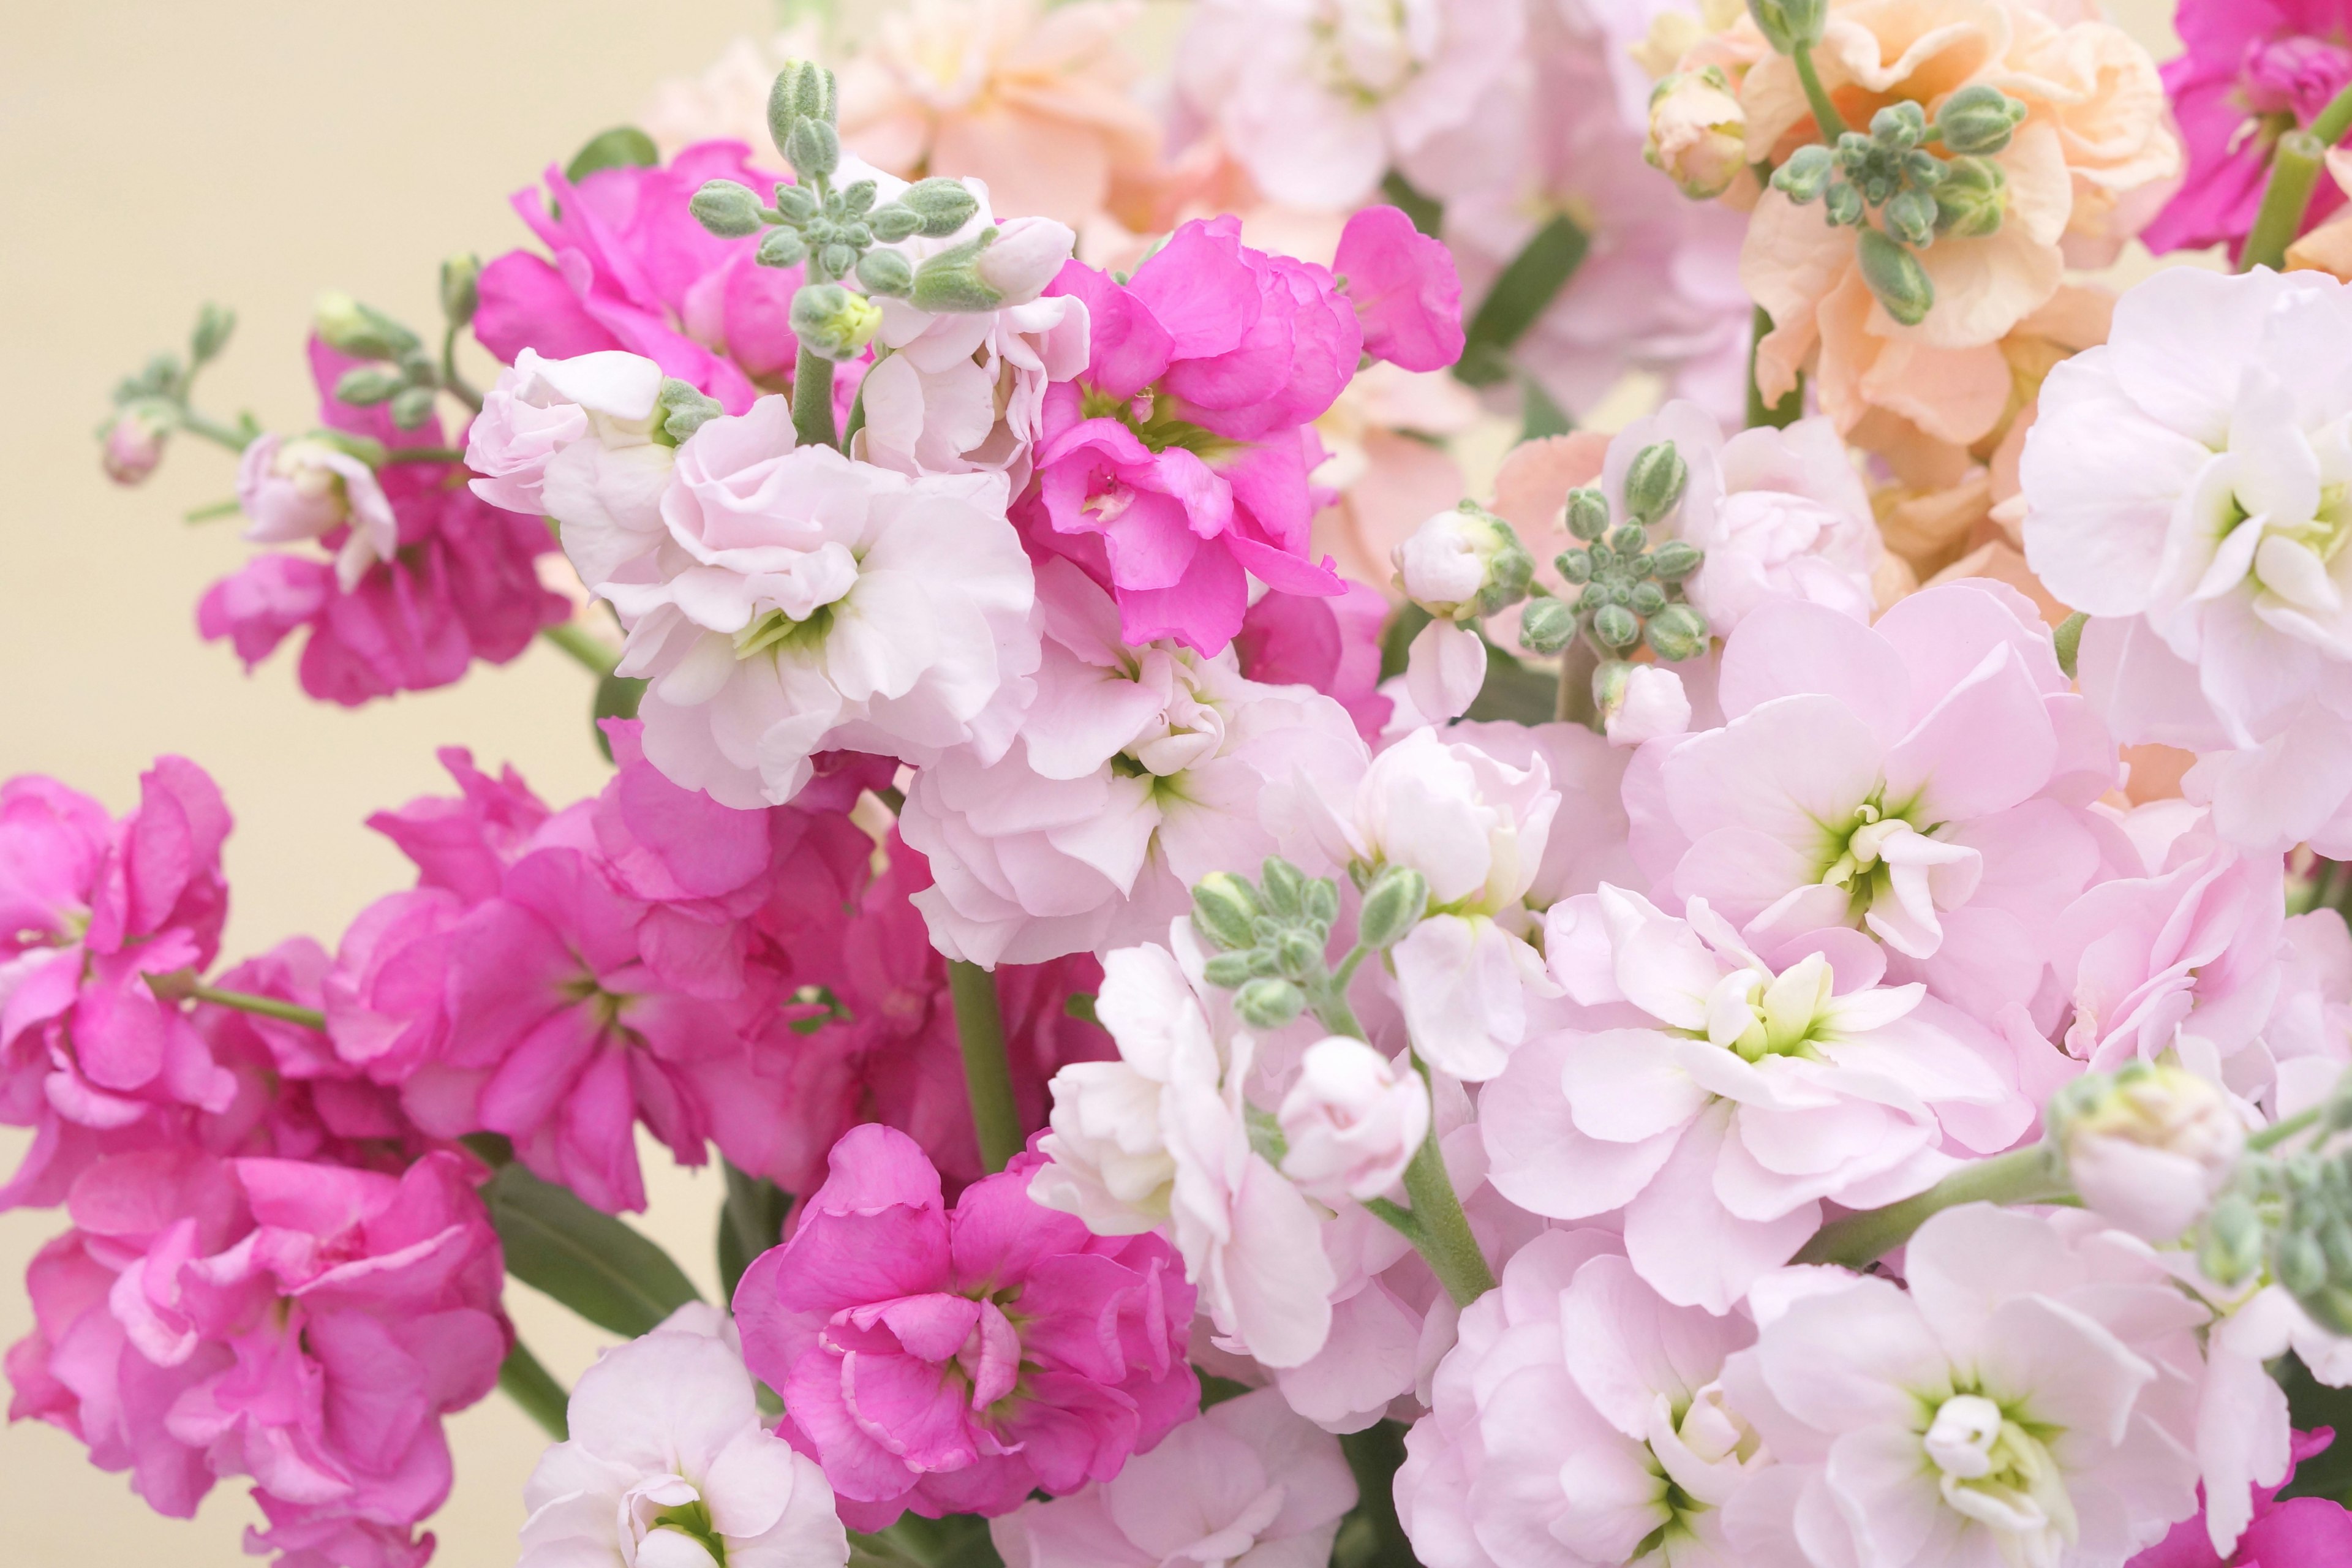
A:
<box><xmin>1479</xmin><ymin>886</ymin><xmax>2035</xmax><ymax>1312</ymax></box>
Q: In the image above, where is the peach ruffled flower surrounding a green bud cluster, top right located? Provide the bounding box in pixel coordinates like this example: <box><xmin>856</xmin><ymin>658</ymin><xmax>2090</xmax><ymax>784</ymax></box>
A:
<box><xmin>1684</xmin><ymin>0</ymin><xmax>2180</xmax><ymax>461</ymax></box>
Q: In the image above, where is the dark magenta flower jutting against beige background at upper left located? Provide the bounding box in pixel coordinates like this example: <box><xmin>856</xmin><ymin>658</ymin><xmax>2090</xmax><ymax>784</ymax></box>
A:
<box><xmin>195</xmin><ymin>341</ymin><xmax>571</xmax><ymax>707</ymax></box>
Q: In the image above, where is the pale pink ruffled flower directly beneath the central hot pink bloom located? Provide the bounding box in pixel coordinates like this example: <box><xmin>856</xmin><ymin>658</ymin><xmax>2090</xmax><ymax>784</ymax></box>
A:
<box><xmin>899</xmin><ymin>559</ymin><xmax>1364</xmax><ymax>966</ymax></box>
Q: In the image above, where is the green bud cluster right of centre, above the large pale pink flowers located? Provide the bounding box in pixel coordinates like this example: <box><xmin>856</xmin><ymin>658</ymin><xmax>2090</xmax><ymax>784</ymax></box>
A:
<box><xmin>1520</xmin><ymin>442</ymin><xmax>1708</xmax><ymax>663</ymax></box>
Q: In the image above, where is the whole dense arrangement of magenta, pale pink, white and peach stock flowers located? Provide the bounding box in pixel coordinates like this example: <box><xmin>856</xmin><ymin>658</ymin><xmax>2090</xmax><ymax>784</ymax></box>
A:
<box><xmin>37</xmin><ymin>0</ymin><xmax>2352</xmax><ymax>1568</ymax></box>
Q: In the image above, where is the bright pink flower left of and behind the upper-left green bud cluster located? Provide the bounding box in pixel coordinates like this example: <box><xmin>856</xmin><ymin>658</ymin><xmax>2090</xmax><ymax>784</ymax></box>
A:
<box><xmin>473</xmin><ymin>141</ymin><xmax>800</xmax><ymax>414</ymax></box>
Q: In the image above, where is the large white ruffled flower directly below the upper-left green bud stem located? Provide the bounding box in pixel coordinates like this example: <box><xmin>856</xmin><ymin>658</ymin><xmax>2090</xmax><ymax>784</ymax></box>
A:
<box><xmin>602</xmin><ymin>398</ymin><xmax>1037</xmax><ymax>809</ymax></box>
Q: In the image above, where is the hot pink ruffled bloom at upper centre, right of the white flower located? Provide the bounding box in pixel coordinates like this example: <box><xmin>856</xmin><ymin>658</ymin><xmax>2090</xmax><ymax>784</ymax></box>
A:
<box><xmin>1021</xmin><ymin>219</ymin><xmax>1362</xmax><ymax>654</ymax></box>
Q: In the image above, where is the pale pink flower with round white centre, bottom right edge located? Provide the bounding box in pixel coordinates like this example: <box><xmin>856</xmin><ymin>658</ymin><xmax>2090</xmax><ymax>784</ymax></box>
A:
<box><xmin>1724</xmin><ymin>1204</ymin><xmax>2204</xmax><ymax>1568</ymax></box>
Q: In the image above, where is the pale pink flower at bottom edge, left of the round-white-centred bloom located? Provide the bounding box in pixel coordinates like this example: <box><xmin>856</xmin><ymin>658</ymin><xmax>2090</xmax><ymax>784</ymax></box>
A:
<box><xmin>1397</xmin><ymin>1229</ymin><xmax>1769</xmax><ymax>1568</ymax></box>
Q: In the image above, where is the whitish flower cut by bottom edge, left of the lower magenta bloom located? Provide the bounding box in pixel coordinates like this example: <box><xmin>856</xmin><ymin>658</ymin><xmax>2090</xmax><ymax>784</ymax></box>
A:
<box><xmin>518</xmin><ymin>1319</ymin><xmax>849</xmax><ymax>1568</ymax></box>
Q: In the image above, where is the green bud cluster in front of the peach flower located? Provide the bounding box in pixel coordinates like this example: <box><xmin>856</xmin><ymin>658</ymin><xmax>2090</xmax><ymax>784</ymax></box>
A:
<box><xmin>1771</xmin><ymin>85</ymin><xmax>2025</xmax><ymax>326</ymax></box>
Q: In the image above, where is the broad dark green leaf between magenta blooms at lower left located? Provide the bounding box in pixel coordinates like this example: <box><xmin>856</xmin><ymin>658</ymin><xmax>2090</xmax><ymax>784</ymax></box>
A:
<box><xmin>482</xmin><ymin>1166</ymin><xmax>701</xmax><ymax>1338</ymax></box>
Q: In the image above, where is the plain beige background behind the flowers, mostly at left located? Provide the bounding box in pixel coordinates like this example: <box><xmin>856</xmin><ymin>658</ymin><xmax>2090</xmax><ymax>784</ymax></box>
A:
<box><xmin>0</xmin><ymin>0</ymin><xmax>2171</xmax><ymax>1568</ymax></box>
